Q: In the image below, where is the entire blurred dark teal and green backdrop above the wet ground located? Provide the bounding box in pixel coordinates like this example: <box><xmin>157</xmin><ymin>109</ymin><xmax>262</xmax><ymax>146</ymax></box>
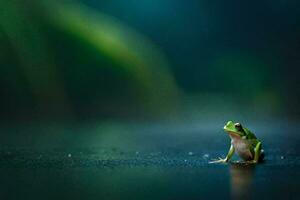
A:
<box><xmin>0</xmin><ymin>0</ymin><xmax>300</xmax><ymax>120</ymax></box>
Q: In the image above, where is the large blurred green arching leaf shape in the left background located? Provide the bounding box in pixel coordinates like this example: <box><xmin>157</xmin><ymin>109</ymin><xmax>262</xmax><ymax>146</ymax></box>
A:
<box><xmin>0</xmin><ymin>0</ymin><xmax>178</xmax><ymax>117</ymax></box>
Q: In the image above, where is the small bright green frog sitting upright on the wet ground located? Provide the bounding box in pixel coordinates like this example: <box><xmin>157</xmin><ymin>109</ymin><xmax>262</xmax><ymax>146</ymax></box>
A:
<box><xmin>210</xmin><ymin>121</ymin><xmax>264</xmax><ymax>163</ymax></box>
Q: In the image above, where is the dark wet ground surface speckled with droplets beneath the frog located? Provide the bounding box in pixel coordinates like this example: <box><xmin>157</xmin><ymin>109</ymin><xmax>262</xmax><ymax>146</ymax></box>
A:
<box><xmin>0</xmin><ymin>123</ymin><xmax>300</xmax><ymax>199</ymax></box>
